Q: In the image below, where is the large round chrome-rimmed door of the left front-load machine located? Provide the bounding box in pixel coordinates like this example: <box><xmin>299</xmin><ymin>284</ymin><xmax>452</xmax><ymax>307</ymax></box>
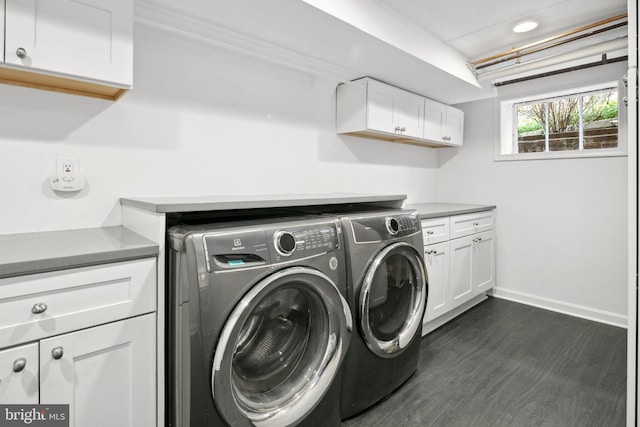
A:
<box><xmin>211</xmin><ymin>267</ymin><xmax>352</xmax><ymax>426</ymax></box>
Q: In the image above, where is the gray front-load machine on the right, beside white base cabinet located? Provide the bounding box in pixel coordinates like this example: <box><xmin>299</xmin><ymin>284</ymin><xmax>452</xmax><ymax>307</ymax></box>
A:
<box><xmin>340</xmin><ymin>210</ymin><xmax>428</xmax><ymax>419</ymax></box>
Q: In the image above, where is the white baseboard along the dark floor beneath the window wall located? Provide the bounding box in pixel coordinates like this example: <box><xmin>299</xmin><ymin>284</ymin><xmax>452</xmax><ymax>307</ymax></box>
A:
<box><xmin>487</xmin><ymin>288</ymin><xmax>628</xmax><ymax>329</ymax></box>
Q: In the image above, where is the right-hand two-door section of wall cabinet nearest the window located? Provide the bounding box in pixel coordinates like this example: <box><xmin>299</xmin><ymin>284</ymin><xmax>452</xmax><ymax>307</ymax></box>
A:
<box><xmin>424</xmin><ymin>99</ymin><xmax>464</xmax><ymax>146</ymax></box>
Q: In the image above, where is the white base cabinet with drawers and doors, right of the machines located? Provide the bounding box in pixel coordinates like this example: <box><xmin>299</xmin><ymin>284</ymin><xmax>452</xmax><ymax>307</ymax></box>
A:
<box><xmin>422</xmin><ymin>212</ymin><xmax>496</xmax><ymax>334</ymax></box>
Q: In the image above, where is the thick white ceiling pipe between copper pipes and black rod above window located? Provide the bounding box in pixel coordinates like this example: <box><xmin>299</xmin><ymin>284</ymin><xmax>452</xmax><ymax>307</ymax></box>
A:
<box><xmin>478</xmin><ymin>37</ymin><xmax>627</xmax><ymax>82</ymax></box>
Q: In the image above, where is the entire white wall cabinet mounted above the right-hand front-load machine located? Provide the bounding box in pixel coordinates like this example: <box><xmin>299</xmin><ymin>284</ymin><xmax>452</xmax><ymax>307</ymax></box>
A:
<box><xmin>336</xmin><ymin>77</ymin><xmax>464</xmax><ymax>147</ymax></box>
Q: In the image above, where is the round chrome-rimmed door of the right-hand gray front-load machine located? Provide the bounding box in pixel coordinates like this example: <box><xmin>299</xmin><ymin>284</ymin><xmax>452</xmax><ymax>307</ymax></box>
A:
<box><xmin>359</xmin><ymin>242</ymin><xmax>427</xmax><ymax>358</ymax></box>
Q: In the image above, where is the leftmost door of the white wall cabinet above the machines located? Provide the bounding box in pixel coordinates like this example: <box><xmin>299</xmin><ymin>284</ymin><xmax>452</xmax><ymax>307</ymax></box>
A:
<box><xmin>367</xmin><ymin>80</ymin><xmax>398</xmax><ymax>133</ymax></box>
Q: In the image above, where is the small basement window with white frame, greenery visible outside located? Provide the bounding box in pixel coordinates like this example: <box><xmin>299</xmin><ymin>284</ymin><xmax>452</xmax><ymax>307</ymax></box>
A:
<box><xmin>495</xmin><ymin>82</ymin><xmax>626</xmax><ymax>160</ymax></box>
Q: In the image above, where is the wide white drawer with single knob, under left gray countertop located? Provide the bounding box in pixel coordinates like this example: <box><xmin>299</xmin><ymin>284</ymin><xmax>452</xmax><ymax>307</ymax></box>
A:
<box><xmin>0</xmin><ymin>258</ymin><xmax>157</xmax><ymax>347</ymax></box>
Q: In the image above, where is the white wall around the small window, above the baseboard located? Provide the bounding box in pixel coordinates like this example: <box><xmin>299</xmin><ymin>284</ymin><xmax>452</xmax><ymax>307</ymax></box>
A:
<box><xmin>438</xmin><ymin>63</ymin><xmax>628</xmax><ymax>325</ymax></box>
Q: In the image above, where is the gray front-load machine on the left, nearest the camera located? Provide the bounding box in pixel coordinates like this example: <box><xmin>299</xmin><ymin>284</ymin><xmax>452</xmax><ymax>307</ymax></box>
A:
<box><xmin>167</xmin><ymin>216</ymin><xmax>351</xmax><ymax>427</ymax></box>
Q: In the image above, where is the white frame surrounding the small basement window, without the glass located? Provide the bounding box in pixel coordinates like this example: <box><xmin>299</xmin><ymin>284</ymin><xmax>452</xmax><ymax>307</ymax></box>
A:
<box><xmin>493</xmin><ymin>81</ymin><xmax>627</xmax><ymax>161</ymax></box>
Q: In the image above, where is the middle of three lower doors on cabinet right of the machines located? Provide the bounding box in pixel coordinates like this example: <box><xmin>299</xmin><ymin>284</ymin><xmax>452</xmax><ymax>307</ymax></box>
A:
<box><xmin>449</xmin><ymin>236</ymin><xmax>474</xmax><ymax>309</ymax></box>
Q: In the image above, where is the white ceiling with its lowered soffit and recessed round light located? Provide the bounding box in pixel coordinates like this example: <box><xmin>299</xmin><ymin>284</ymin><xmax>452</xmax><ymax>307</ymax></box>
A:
<box><xmin>135</xmin><ymin>0</ymin><xmax>626</xmax><ymax>104</ymax></box>
